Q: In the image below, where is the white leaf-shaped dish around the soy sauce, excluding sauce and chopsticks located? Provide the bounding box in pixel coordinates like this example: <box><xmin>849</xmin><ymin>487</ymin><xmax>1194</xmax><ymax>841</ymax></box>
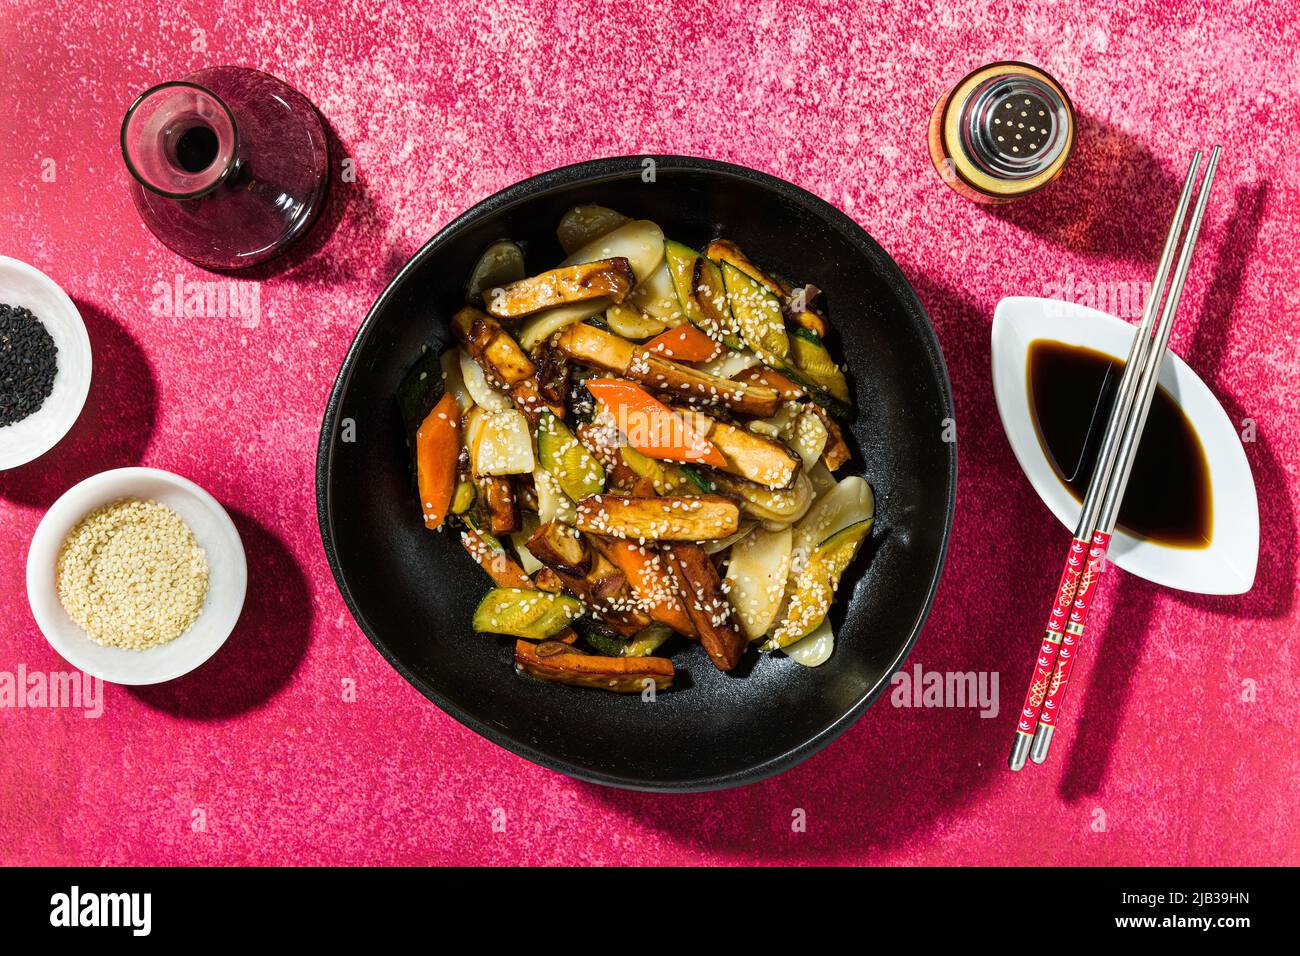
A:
<box><xmin>993</xmin><ymin>297</ymin><xmax>1260</xmax><ymax>594</ymax></box>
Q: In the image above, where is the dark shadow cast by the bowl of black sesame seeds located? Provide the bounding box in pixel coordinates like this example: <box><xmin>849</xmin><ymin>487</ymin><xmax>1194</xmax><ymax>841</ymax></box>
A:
<box><xmin>0</xmin><ymin>299</ymin><xmax>157</xmax><ymax>509</ymax></box>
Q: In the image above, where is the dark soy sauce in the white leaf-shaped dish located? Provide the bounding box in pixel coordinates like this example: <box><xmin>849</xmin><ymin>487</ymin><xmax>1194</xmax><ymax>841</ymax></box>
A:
<box><xmin>1028</xmin><ymin>338</ymin><xmax>1213</xmax><ymax>548</ymax></box>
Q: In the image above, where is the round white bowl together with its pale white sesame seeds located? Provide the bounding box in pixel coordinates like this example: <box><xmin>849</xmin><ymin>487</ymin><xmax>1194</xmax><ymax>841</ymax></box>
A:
<box><xmin>27</xmin><ymin>468</ymin><xmax>248</xmax><ymax>684</ymax></box>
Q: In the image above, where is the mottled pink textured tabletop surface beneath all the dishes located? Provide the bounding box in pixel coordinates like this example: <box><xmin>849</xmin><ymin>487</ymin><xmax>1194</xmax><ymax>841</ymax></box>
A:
<box><xmin>0</xmin><ymin>0</ymin><xmax>1300</xmax><ymax>864</ymax></box>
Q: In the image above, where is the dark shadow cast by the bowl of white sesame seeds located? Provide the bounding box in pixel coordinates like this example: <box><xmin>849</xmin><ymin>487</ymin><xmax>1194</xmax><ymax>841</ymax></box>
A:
<box><xmin>131</xmin><ymin>507</ymin><xmax>312</xmax><ymax>721</ymax></box>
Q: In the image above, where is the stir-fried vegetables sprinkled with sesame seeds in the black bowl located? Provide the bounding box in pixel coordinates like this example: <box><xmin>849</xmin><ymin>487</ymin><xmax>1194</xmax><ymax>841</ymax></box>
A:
<box><xmin>398</xmin><ymin>206</ymin><xmax>875</xmax><ymax>693</ymax></box>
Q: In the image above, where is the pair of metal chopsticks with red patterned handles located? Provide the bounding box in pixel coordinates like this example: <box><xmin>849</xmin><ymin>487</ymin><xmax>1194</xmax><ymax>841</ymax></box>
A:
<box><xmin>1008</xmin><ymin>146</ymin><xmax>1222</xmax><ymax>770</ymax></box>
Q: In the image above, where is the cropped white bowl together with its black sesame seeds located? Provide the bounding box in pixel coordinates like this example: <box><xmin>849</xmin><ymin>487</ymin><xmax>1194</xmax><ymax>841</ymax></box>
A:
<box><xmin>0</xmin><ymin>256</ymin><xmax>91</xmax><ymax>471</ymax></box>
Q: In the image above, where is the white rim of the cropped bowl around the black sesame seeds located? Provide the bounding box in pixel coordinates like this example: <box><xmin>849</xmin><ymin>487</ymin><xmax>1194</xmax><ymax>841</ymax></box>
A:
<box><xmin>0</xmin><ymin>256</ymin><xmax>91</xmax><ymax>471</ymax></box>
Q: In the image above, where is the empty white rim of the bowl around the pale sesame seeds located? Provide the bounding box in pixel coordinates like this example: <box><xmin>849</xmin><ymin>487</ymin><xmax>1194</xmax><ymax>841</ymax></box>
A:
<box><xmin>27</xmin><ymin>468</ymin><xmax>248</xmax><ymax>684</ymax></box>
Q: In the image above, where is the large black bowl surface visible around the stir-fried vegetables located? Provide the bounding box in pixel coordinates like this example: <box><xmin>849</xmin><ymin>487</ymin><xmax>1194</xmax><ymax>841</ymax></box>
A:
<box><xmin>316</xmin><ymin>156</ymin><xmax>957</xmax><ymax>791</ymax></box>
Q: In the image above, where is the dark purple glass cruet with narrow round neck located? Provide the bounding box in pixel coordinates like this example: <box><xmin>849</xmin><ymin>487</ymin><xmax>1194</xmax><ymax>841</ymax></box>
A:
<box><xmin>122</xmin><ymin>66</ymin><xmax>329</xmax><ymax>269</ymax></box>
